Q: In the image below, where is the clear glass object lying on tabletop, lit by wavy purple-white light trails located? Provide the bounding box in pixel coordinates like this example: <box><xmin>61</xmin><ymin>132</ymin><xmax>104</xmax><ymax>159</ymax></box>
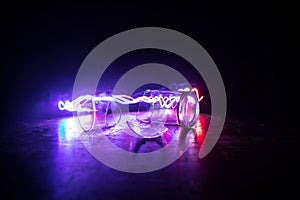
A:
<box><xmin>58</xmin><ymin>88</ymin><xmax>203</xmax><ymax>138</ymax></box>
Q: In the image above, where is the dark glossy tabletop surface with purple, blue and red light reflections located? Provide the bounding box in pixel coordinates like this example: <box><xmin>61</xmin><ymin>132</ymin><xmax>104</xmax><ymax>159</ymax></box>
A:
<box><xmin>1</xmin><ymin>115</ymin><xmax>299</xmax><ymax>199</ymax></box>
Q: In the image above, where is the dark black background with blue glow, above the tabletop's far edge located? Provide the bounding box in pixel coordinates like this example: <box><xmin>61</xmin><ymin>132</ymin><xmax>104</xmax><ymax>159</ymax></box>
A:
<box><xmin>1</xmin><ymin>2</ymin><xmax>293</xmax><ymax>122</ymax></box>
